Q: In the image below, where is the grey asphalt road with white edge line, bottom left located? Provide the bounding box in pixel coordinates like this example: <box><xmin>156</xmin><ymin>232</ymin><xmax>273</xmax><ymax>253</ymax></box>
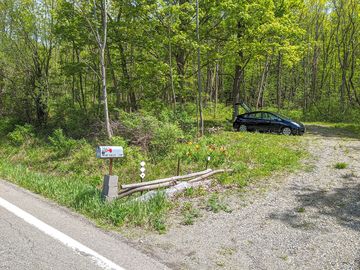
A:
<box><xmin>0</xmin><ymin>180</ymin><xmax>168</xmax><ymax>270</ymax></box>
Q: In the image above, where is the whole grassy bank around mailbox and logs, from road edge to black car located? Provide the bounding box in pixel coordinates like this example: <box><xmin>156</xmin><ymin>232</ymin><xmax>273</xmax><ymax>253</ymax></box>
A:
<box><xmin>0</xmin><ymin>117</ymin><xmax>305</xmax><ymax>231</ymax></box>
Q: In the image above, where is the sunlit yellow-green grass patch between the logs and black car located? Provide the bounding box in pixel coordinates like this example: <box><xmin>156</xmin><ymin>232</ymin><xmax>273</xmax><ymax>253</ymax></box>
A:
<box><xmin>171</xmin><ymin>132</ymin><xmax>305</xmax><ymax>186</ymax></box>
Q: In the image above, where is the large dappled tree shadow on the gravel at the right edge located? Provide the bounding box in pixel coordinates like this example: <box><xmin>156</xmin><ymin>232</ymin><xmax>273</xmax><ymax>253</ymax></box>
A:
<box><xmin>270</xmin><ymin>181</ymin><xmax>360</xmax><ymax>231</ymax></box>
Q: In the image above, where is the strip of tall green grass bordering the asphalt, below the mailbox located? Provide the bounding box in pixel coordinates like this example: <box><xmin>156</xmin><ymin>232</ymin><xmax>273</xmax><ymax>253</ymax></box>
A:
<box><xmin>0</xmin><ymin>159</ymin><xmax>170</xmax><ymax>232</ymax></box>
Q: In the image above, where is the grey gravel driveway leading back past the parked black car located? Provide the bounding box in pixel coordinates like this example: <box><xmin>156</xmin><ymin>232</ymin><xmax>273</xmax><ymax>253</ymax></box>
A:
<box><xmin>138</xmin><ymin>126</ymin><xmax>360</xmax><ymax>269</ymax></box>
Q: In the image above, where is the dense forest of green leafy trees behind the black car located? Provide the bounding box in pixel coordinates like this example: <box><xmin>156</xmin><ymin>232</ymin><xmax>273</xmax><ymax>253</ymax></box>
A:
<box><xmin>0</xmin><ymin>0</ymin><xmax>360</xmax><ymax>137</ymax></box>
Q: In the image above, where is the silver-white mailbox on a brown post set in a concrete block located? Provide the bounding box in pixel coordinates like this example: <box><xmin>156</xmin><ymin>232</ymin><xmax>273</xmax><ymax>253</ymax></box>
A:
<box><xmin>96</xmin><ymin>146</ymin><xmax>124</xmax><ymax>201</ymax></box>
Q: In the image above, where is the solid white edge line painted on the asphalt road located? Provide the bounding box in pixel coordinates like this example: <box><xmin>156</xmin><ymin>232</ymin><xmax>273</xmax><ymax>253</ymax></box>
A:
<box><xmin>0</xmin><ymin>197</ymin><xmax>125</xmax><ymax>270</ymax></box>
